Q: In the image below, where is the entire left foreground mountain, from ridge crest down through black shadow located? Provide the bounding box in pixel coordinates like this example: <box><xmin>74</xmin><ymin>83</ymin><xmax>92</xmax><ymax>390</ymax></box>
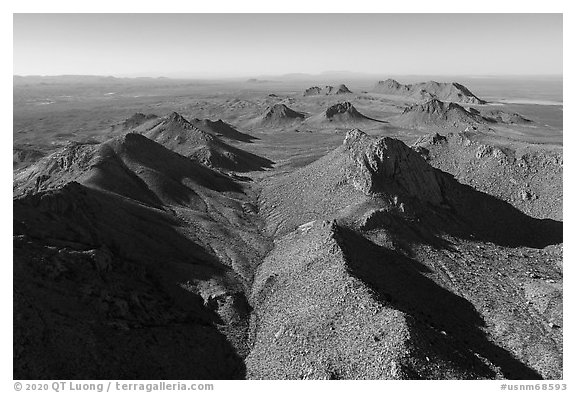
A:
<box><xmin>13</xmin><ymin>133</ymin><xmax>268</xmax><ymax>379</ymax></box>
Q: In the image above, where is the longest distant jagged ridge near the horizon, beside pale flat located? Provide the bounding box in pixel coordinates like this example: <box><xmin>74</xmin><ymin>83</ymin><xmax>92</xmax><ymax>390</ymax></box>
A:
<box><xmin>373</xmin><ymin>79</ymin><xmax>486</xmax><ymax>104</ymax></box>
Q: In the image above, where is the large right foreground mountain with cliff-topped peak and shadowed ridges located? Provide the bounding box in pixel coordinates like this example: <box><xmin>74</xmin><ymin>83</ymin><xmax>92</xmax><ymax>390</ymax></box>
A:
<box><xmin>255</xmin><ymin>131</ymin><xmax>562</xmax><ymax>379</ymax></box>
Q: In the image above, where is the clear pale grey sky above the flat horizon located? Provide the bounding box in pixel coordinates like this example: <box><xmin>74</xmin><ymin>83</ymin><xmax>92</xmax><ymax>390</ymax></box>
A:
<box><xmin>14</xmin><ymin>14</ymin><xmax>562</xmax><ymax>77</ymax></box>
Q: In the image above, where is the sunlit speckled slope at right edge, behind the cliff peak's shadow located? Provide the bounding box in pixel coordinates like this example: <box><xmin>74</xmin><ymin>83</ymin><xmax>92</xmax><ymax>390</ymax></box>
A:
<box><xmin>414</xmin><ymin>132</ymin><xmax>563</xmax><ymax>220</ymax></box>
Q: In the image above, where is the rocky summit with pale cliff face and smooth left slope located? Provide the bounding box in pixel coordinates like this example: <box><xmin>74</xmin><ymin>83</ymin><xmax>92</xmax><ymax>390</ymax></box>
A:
<box><xmin>262</xmin><ymin>129</ymin><xmax>444</xmax><ymax>233</ymax></box>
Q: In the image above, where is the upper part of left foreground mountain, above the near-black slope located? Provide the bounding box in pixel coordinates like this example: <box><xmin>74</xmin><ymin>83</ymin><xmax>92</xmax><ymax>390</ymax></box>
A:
<box><xmin>15</xmin><ymin>134</ymin><xmax>268</xmax><ymax>278</ymax></box>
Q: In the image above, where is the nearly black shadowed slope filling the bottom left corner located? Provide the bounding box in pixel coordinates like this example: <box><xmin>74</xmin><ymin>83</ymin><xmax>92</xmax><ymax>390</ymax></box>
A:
<box><xmin>14</xmin><ymin>182</ymin><xmax>244</xmax><ymax>379</ymax></box>
